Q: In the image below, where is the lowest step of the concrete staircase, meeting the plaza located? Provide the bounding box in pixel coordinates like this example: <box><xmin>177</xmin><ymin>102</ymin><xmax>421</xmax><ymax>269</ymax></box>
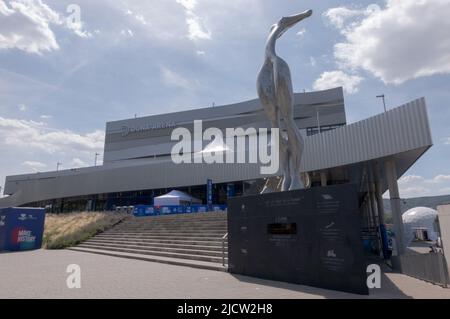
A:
<box><xmin>69</xmin><ymin>247</ymin><xmax>228</xmax><ymax>272</ymax></box>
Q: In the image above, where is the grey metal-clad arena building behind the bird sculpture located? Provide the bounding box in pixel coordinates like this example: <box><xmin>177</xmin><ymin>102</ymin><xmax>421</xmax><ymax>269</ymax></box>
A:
<box><xmin>0</xmin><ymin>88</ymin><xmax>432</xmax><ymax>254</ymax></box>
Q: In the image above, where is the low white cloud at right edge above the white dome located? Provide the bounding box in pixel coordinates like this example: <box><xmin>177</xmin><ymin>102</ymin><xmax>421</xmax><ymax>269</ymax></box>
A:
<box><xmin>398</xmin><ymin>174</ymin><xmax>450</xmax><ymax>198</ymax></box>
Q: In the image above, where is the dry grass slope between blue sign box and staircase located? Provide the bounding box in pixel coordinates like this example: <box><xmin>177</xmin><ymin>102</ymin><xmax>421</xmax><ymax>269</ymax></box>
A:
<box><xmin>42</xmin><ymin>212</ymin><xmax>129</xmax><ymax>249</ymax></box>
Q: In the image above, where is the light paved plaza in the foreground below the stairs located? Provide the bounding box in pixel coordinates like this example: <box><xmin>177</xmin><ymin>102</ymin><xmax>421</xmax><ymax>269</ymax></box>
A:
<box><xmin>0</xmin><ymin>250</ymin><xmax>450</xmax><ymax>299</ymax></box>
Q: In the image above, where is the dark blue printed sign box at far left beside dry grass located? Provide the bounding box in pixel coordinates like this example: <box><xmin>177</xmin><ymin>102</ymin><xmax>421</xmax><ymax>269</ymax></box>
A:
<box><xmin>0</xmin><ymin>208</ymin><xmax>45</xmax><ymax>251</ymax></box>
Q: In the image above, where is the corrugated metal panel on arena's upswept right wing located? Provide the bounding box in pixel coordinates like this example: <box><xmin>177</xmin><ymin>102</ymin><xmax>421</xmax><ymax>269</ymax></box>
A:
<box><xmin>302</xmin><ymin>98</ymin><xmax>432</xmax><ymax>171</ymax></box>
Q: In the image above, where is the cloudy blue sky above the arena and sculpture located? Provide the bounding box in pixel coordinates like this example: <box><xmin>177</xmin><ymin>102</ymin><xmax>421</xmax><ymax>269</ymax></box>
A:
<box><xmin>0</xmin><ymin>0</ymin><xmax>450</xmax><ymax>197</ymax></box>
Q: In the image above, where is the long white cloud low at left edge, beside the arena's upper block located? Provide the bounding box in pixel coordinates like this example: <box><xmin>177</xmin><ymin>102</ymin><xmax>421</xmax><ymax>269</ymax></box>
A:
<box><xmin>0</xmin><ymin>117</ymin><xmax>104</xmax><ymax>154</ymax></box>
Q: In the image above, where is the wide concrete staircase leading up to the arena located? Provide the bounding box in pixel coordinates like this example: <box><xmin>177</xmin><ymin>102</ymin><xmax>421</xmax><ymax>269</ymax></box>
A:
<box><xmin>70</xmin><ymin>212</ymin><xmax>228</xmax><ymax>271</ymax></box>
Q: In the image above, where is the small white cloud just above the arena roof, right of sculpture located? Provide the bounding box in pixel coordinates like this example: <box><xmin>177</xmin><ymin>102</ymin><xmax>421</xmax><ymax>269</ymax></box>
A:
<box><xmin>313</xmin><ymin>71</ymin><xmax>363</xmax><ymax>94</ymax></box>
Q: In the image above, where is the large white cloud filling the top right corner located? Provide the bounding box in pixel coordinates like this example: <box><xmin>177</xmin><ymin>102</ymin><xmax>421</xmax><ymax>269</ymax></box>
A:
<box><xmin>324</xmin><ymin>0</ymin><xmax>450</xmax><ymax>84</ymax></box>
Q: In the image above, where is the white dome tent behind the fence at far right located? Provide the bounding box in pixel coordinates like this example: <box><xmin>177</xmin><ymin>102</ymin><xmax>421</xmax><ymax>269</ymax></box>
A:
<box><xmin>402</xmin><ymin>207</ymin><xmax>439</xmax><ymax>247</ymax></box>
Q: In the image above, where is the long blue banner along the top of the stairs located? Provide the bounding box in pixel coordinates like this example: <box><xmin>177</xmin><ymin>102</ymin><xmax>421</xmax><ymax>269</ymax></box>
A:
<box><xmin>133</xmin><ymin>205</ymin><xmax>227</xmax><ymax>217</ymax></box>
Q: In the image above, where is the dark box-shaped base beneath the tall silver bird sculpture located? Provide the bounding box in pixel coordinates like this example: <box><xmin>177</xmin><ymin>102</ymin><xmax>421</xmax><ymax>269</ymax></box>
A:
<box><xmin>228</xmin><ymin>184</ymin><xmax>368</xmax><ymax>294</ymax></box>
